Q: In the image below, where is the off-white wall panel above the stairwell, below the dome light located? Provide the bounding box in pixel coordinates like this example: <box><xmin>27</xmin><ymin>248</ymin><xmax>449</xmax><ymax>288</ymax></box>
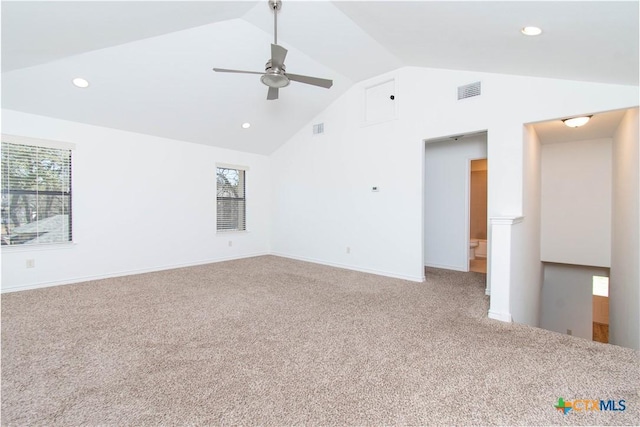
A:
<box><xmin>541</xmin><ymin>138</ymin><xmax>612</xmax><ymax>267</ymax></box>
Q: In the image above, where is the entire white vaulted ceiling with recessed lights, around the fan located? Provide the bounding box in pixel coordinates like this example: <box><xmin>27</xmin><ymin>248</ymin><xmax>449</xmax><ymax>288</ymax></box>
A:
<box><xmin>2</xmin><ymin>0</ymin><xmax>638</xmax><ymax>154</ymax></box>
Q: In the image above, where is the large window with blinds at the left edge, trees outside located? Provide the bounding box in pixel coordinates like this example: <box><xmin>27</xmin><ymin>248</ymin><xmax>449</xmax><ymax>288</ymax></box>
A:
<box><xmin>2</xmin><ymin>141</ymin><xmax>72</xmax><ymax>245</ymax></box>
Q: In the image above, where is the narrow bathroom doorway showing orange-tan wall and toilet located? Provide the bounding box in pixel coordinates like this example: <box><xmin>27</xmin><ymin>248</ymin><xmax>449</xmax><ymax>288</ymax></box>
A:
<box><xmin>469</xmin><ymin>158</ymin><xmax>489</xmax><ymax>274</ymax></box>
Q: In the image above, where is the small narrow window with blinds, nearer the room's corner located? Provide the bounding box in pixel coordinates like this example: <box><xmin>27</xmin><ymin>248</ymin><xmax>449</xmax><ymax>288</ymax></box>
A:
<box><xmin>216</xmin><ymin>167</ymin><xmax>247</xmax><ymax>231</ymax></box>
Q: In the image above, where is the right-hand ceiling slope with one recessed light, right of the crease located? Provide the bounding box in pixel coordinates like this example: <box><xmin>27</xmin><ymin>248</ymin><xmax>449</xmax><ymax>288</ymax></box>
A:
<box><xmin>336</xmin><ymin>1</ymin><xmax>638</xmax><ymax>85</ymax></box>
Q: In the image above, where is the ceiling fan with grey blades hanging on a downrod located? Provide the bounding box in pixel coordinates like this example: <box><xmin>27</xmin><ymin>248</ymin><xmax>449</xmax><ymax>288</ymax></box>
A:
<box><xmin>213</xmin><ymin>0</ymin><xmax>333</xmax><ymax>100</ymax></box>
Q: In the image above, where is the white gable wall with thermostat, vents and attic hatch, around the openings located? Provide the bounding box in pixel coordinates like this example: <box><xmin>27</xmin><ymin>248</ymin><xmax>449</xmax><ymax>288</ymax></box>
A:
<box><xmin>272</xmin><ymin>67</ymin><xmax>638</xmax><ymax>319</ymax></box>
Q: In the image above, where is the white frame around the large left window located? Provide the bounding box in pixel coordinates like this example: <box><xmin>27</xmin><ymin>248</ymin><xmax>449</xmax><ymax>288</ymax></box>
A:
<box><xmin>1</xmin><ymin>133</ymin><xmax>76</xmax><ymax>247</ymax></box>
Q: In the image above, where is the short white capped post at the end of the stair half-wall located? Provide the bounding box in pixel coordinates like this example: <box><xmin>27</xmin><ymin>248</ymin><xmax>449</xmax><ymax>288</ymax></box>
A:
<box><xmin>487</xmin><ymin>216</ymin><xmax>524</xmax><ymax>322</ymax></box>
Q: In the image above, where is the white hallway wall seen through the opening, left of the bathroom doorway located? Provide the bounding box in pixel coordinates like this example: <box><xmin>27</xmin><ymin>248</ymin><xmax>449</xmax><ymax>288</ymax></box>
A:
<box><xmin>424</xmin><ymin>133</ymin><xmax>484</xmax><ymax>271</ymax></box>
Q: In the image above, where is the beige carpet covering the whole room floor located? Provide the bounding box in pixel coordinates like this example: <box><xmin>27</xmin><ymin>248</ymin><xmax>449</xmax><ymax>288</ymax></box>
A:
<box><xmin>2</xmin><ymin>256</ymin><xmax>640</xmax><ymax>426</ymax></box>
